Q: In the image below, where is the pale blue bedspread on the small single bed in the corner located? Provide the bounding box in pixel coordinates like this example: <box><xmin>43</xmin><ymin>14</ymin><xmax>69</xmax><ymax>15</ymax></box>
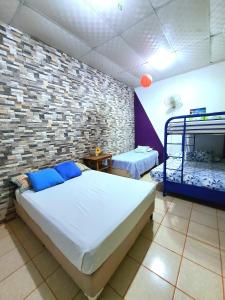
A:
<box><xmin>112</xmin><ymin>150</ymin><xmax>159</xmax><ymax>179</ymax></box>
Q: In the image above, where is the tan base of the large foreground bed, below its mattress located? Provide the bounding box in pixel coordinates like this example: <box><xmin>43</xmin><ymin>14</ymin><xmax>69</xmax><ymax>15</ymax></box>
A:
<box><xmin>15</xmin><ymin>196</ymin><xmax>155</xmax><ymax>300</ymax></box>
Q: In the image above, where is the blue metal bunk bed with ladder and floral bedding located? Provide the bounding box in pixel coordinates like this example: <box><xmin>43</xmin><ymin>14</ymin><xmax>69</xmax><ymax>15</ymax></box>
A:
<box><xmin>150</xmin><ymin>112</ymin><xmax>225</xmax><ymax>207</ymax></box>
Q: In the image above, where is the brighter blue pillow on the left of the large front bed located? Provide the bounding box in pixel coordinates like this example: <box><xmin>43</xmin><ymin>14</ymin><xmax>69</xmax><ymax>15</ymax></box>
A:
<box><xmin>27</xmin><ymin>168</ymin><xmax>65</xmax><ymax>192</ymax></box>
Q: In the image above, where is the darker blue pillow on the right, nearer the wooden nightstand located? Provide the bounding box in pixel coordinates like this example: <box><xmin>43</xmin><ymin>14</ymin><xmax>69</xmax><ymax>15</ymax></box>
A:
<box><xmin>55</xmin><ymin>161</ymin><xmax>82</xmax><ymax>180</ymax></box>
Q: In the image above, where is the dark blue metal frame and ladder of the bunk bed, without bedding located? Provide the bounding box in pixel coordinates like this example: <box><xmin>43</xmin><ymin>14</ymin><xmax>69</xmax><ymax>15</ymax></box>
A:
<box><xmin>163</xmin><ymin>111</ymin><xmax>225</xmax><ymax>207</ymax></box>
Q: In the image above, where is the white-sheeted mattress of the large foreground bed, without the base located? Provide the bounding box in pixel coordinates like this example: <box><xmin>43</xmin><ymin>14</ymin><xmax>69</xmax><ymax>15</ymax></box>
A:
<box><xmin>16</xmin><ymin>171</ymin><xmax>155</xmax><ymax>274</ymax></box>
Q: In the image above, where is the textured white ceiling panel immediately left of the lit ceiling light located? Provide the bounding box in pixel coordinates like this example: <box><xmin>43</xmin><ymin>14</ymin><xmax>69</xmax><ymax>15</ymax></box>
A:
<box><xmin>96</xmin><ymin>36</ymin><xmax>144</xmax><ymax>69</ymax></box>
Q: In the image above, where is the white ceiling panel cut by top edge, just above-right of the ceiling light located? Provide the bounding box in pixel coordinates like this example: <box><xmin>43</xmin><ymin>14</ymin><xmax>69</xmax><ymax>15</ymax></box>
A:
<box><xmin>157</xmin><ymin>0</ymin><xmax>209</xmax><ymax>50</ymax></box>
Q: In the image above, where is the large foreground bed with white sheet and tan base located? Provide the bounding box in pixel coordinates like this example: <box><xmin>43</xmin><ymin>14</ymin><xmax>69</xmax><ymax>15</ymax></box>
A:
<box><xmin>15</xmin><ymin>170</ymin><xmax>155</xmax><ymax>299</ymax></box>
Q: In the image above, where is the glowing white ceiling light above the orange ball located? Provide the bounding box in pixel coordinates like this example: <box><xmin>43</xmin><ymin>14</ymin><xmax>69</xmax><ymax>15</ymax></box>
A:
<box><xmin>149</xmin><ymin>48</ymin><xmax>176</xmax><ymax>70</ymax></box>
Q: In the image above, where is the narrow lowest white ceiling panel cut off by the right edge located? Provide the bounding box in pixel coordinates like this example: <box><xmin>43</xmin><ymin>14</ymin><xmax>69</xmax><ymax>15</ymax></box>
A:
<box><xmin>211</xmin><ymin>34</ymin><xmax>225</xmax><ymax>62</ymax></box>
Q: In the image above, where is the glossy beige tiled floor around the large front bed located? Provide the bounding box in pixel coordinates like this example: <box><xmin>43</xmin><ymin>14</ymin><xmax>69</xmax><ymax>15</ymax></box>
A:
<box><xmin>0</xmin><ymin>177</ymin><xmax>225</xmax><ymax>300</ymax></box>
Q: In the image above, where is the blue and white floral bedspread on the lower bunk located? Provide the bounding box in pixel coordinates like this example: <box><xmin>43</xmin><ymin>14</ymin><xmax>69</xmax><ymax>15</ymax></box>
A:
<box><xmin>150</xmin><ymin>158</ymin><xmax>225</xmax><ymax>192</ymax></box>
